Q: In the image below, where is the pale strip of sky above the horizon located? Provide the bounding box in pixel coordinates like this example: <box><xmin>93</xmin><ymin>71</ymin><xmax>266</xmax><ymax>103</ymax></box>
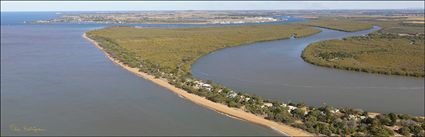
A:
<box><xmin>1</xmin><ymin>1</ymin><xmax>424</xmax><ymax>11</ymax></box>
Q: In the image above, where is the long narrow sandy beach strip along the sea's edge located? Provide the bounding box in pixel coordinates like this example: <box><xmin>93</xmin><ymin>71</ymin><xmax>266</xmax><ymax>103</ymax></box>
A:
<box><xmin>83</xmin><ymin>33</ymin><xmax>313</xmax><ymax>136</ymax></box>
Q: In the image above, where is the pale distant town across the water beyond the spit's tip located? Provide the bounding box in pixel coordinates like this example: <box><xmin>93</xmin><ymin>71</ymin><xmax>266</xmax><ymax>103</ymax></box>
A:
<box><xmin>33</xmin><ymin>11</ymin><xmax>287</xmax><ymax>24</ymax></box>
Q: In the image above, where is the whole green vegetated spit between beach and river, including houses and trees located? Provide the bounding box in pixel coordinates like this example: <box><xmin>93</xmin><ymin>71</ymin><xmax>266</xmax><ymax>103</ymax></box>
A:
<box><xmin>87</xmin><ymin>24</ymin><xmax>425</xmax><ymax>136</ymax></box>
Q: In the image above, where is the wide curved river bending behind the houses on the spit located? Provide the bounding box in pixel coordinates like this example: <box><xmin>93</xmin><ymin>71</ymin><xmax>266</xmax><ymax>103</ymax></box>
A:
<box><xmin>192</xmin><ymin>27</ymin><xmax>424</xmax><ymax>115</ymax></box>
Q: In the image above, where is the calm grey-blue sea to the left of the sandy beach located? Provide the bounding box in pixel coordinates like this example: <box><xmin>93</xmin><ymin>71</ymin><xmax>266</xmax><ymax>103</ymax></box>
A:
<box><xmin>1</xmin><ymin>12</ymin><xmax>279</xmax><ymax>135</ymax></box>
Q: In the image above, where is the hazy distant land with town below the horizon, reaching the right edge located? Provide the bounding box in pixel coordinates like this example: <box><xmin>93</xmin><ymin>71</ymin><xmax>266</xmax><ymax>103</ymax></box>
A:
<box><xmin>28</xmin><ymin>9</ymin><xmax>424</xmax><ymax>24</ymax></box>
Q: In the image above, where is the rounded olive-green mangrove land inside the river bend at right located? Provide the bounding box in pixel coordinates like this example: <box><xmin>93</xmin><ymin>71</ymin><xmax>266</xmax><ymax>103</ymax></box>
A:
<box><xmin>302</xmin><ymin>33</ymin><xmax>425</xmax><ymax>77</ymax></box>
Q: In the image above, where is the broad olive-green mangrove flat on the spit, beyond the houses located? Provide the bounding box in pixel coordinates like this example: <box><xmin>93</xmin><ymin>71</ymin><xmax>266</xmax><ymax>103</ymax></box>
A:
<box><xmin>89</xmin><ymin>25</ymin><xmax>320</xmax><ymax>73</ymax></box>
